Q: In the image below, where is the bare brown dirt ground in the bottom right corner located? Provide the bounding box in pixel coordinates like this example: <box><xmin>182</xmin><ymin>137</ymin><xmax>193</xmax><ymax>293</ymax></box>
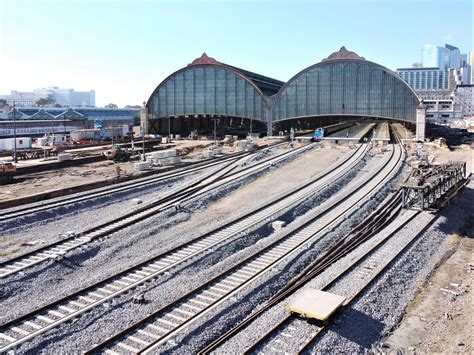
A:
<box><xmin>385</xmin><ymin>204</ymin><xmax>474</xmax><ymax>354</ymax></box>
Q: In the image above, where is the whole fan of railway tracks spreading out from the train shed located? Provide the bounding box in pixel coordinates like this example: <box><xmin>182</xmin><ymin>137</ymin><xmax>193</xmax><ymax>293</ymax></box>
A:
<box><xmin>0</xmin><ymin>123</ymin><xmax>470</xmax><ymax>354</ymax></box>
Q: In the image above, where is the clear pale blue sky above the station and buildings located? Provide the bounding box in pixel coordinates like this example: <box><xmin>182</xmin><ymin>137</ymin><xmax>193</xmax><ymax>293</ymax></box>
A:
<box><xmin>0</xmin><ymin>0</ymin><xmax>473</xmax><ymax>106</ymax></box>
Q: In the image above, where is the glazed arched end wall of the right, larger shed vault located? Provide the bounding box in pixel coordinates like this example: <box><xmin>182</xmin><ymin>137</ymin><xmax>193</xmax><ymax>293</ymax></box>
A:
<box><xmin>273</xmin><ymin>59</ymin><xmax>419</xmax><ymax>122</ymax></box>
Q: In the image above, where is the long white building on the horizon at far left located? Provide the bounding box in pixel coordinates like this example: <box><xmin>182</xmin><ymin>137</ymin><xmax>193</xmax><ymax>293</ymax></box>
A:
<box><xmin>0</xmin><ymin>86</ymin><xmax>95</xmax><ymax>107</ymax></box>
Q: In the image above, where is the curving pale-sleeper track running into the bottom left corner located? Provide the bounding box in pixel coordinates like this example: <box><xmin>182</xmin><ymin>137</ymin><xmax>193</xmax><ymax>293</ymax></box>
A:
<box><xmin>0</xmin><ymin>144</ymin><xmax>368</xmax><ymax>350</ymax></box>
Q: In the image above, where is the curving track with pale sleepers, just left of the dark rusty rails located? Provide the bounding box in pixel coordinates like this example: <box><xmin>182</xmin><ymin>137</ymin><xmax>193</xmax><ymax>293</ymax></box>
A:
<box><xmin>79</xmin><ymin>141</ymin><xmax>403</xmax><ymax>354</ymax></box>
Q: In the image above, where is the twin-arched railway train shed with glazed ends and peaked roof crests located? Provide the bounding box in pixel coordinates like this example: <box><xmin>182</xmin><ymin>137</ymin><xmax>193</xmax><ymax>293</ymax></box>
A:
<box><xmin>146</xmin><ymin>47</ymin><xmax>419</xmax><ymax>139</ymax></box>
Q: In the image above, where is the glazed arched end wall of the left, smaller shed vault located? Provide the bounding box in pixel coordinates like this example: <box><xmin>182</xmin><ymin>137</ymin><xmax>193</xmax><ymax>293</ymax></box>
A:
<box><xmin>147</xmin><ymin>64</ymin><xmax>269</xmax><ymax>122</ymax></box>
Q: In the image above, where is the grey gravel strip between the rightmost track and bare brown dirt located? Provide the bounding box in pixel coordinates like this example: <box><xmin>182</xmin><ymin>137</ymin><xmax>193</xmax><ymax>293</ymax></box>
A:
<box><xmin>314</xmin><ymin>182</ymin><xmax>474</xmax><ymax>353</ymax></box>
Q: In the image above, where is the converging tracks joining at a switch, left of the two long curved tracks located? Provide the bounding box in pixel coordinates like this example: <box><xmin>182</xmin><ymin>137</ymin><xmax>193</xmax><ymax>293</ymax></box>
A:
<box><xmin>0</xmin><ymin>144</ymin><xmax>312</xmax><ymax>279</ymax></box>
